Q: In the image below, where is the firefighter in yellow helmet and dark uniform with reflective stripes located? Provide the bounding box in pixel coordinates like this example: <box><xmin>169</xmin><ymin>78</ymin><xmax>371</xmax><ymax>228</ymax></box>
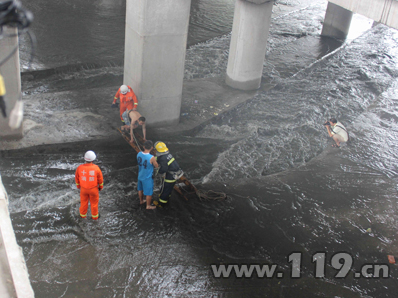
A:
<box><xmin>153</xmin><ymin>142</ymin><xmax>184</xmax><ymax>207</ymax></box>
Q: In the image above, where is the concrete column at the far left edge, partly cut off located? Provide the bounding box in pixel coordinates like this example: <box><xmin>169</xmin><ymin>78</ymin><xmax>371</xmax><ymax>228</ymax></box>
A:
<box><xmin>0</xmin><ymin>26</ymin><xmax>22</xmax><ymax>140</ymax></box>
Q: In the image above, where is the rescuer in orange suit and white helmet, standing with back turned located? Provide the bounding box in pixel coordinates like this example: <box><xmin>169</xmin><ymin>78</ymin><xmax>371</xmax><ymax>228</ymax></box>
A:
<box><xmin>75</xmin><ymin>150</ymin><xmax>104</xmax><ymax>220</ymax></box>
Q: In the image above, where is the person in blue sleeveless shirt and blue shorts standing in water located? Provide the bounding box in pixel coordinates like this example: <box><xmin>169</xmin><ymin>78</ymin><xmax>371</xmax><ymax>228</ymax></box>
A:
<box><xmin>137</xmin><ymin>140</ymin><xmax>159</xmax><ymax>209</ymax></box>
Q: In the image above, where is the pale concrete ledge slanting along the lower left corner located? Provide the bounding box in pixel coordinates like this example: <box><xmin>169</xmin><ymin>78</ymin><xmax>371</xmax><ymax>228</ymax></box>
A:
<box><xmin>0</xmin><ymin>176</ymin><xmax>34</xmax><ymax>298</ymax></box>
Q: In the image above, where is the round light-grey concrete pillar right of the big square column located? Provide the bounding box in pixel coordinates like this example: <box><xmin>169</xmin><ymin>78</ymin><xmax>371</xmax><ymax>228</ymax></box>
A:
<box><xmin>225</xmin><ymin>0</ymin><xmax>274</xmax><ymax>90</ymax></box>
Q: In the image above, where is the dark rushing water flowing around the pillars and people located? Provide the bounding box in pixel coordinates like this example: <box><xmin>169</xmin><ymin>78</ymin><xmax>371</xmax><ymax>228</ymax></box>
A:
<box><xmin>0</xmin><ymin>0</ymin><xmax>398</xmax><ymax>297</ymax></box>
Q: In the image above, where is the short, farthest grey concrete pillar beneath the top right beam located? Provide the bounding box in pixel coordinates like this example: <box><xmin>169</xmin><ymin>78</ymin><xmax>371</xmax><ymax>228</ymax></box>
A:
<box><xmin>321</xmin><ymin>2</ymin><xmax>353</xmax><ymax>39</ymax></box>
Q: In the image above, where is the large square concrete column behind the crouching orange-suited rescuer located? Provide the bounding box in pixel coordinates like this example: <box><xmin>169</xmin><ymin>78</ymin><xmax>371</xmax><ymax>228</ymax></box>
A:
<box><xmin>124</xmin><ymin>0</ymin><xmax>191</xmax><ymax>126</ymax></box>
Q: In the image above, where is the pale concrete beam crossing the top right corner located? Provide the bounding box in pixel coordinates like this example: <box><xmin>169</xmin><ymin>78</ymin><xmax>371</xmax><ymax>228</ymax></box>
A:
<box><xmin>329</xmin><ymin>0</ymin><xmax>398</xmax><ymax>29</ymax></box>
